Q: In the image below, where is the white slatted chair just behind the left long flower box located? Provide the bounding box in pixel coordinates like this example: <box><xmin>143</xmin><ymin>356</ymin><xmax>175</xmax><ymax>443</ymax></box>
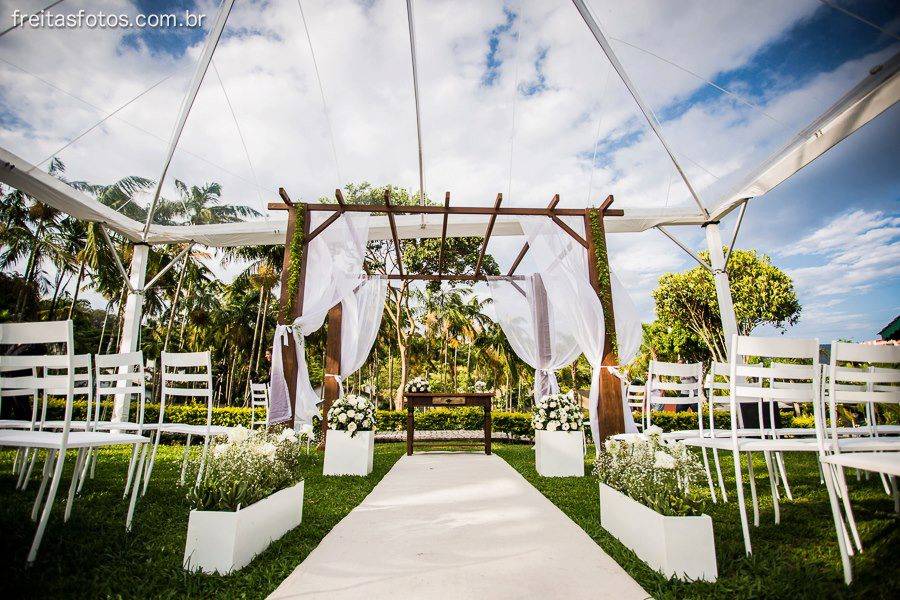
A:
<box><xmin>144</xmin><ymin>352</ymin><xmax>234</xmax><ymax>492</ymax></box>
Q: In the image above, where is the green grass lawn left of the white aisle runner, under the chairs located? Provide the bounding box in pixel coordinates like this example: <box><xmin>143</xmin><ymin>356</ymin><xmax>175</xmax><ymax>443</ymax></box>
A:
<box><xmin>0</xmin><ymin>444</ymin><xmax>404</xmax><ymax>598</ymax></box>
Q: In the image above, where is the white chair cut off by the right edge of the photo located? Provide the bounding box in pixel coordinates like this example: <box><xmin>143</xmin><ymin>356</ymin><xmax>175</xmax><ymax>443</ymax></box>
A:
<box><xmin>816</xmin><ymin>342</ymin><xmax>900</xmax><ymax>584</ymax></box>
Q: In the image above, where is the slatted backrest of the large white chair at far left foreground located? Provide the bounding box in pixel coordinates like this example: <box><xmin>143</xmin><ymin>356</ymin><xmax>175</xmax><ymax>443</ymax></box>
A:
<box><xmin>0</xmin><ymin>321</ymin><xmax>76</xmax><ymax>434</ymax></box>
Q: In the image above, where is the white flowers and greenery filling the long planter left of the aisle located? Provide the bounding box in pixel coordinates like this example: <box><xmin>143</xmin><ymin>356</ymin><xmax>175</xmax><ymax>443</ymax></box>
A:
<box><xmin>187</xmin><ymin>427</ymin><xmax>306</xmax><ymax>511</ymax></box>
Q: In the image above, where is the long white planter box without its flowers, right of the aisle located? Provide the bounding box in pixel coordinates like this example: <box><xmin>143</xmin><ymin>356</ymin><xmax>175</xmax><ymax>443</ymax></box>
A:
<box><xmin>600</xmin><ymin>483</ymin><xmax>718</xmax><ymax>581</ymax></box>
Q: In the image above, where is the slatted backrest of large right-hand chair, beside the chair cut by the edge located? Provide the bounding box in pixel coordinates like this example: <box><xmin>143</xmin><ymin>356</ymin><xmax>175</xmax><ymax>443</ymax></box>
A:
<box><xmin>728</xmin><ymin>335</ymin><xmax>821</xmax><ymax>428</ymax></box>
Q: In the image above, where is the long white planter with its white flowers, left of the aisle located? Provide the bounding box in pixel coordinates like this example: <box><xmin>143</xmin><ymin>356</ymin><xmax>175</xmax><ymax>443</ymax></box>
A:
<box><xmin>184</xmin><ymin>427</ymin><xmax>304</xmax><ymax>575</ymax></box>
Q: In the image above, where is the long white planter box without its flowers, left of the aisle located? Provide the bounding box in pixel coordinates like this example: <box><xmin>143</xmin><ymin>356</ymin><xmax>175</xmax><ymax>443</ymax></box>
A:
<box><xmin>184</xmin><ymin>481</ymin><xmax>303</xmax><ymax>575</ymax></box>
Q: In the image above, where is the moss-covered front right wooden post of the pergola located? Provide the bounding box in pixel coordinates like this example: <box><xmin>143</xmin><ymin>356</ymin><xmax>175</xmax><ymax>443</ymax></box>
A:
<box><xmin>584</xmin><ymin>196</ymin><xmax>625</xmax><ymax>442</ymax></box>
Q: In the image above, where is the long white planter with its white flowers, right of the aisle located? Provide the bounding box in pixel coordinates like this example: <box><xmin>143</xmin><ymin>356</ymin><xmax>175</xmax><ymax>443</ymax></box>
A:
<box><xmin>594</xmin><ymin>427</ymin><xmax>717</xmax><ymax>581</ymax></box>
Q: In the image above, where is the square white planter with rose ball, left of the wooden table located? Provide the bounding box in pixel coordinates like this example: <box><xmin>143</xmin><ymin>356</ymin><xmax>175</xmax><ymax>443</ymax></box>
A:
<box><xmin>323</xmin><ymin>394</ymin><xmax>375</xmax><ymax>475</ymax></box>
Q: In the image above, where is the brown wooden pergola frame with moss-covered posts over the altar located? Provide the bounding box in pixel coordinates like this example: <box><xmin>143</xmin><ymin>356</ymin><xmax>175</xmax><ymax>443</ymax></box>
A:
<box><xmin>268</xmin><ymin>188</ymin><xmax>625</xmax><ymax>440</ymax></box>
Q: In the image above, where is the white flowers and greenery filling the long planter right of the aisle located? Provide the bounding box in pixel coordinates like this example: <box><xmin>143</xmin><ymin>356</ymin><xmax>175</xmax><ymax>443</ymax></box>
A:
<box><xmin>594</xmin><ymin>426</ymin><xmax>705</xmax><ymax>516</ymax></box>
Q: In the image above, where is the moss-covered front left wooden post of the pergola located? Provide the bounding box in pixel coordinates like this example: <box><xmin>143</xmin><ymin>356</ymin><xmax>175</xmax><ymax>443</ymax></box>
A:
<box><xmin>278</xmin><ymin>204</ymin><xmax>310</xmax><ymax>427</ymax></box>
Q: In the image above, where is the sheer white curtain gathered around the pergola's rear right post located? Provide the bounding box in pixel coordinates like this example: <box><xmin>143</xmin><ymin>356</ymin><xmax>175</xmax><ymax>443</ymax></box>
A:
<box><xmin>488</xmin><ymin>275</ymin><xmax>581</xmax><ymax>401</ymax></box>
